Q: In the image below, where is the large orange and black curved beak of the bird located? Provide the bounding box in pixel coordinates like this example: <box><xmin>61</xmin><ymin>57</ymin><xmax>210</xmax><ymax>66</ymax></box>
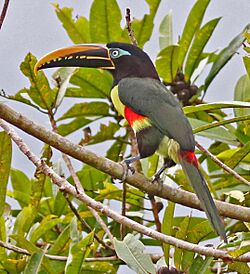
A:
<box><xmin>34</xmin><ymin>44</ymin><xmax>115</xmax><ymax>74</ymax></box>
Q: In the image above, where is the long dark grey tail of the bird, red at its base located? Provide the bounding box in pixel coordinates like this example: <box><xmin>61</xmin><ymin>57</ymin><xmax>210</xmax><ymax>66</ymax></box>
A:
<box><xmin>180</xmin><ymin>152</ymin><xmax>227</xmax><ymax>242</ymax></box>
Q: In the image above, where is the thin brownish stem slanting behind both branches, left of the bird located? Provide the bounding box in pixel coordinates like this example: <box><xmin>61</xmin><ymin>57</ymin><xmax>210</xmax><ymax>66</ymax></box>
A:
<box><xmin>48</xmin><ymin>111</ymin><xmax>113</xmax><ymax>243</ymax></box>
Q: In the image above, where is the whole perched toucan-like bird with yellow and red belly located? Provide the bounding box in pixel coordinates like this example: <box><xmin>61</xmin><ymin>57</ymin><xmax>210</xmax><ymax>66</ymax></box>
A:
<box><xmin>34</xmin><ymin>42</ymin><xmax>227</xmax><ymax>242</ymax></box>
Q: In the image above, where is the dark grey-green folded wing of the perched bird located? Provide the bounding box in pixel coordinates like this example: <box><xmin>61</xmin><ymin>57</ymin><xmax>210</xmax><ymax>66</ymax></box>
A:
<box><xmin>118</xmin><ymin>78</ymin><xmax>195</xmax><ymax>151</ymax></box>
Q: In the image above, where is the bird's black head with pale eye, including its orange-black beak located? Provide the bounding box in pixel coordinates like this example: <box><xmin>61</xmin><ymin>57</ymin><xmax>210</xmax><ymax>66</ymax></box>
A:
<box><xmin>34</xmin><ymin>42</ymin><xmax>159</xmax><ymax>83</ymax></box>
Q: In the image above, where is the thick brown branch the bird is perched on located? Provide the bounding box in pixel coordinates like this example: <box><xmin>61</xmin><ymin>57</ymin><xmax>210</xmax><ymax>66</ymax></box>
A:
<box><xmin>0</xmin><ymin>103</ymin><xmax>250</xmax><ymax>222</ymax></box>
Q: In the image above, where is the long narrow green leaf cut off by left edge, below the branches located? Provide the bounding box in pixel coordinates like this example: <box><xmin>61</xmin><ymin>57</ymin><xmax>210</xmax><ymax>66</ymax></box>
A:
<box><xmin>0</xmin><ymin>131</ymin><xmax>12</xmax><ymax>216</ymax></box>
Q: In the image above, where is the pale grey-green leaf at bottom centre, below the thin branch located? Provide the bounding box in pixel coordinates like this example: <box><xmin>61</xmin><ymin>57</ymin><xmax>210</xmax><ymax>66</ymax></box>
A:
<box><xmin>114</xmin><ymin>234</ymin><xmax>156</xmax><ymax>274</ymax></box>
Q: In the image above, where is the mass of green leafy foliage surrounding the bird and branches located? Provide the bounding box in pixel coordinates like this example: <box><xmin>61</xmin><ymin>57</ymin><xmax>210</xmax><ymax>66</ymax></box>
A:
<box><xmin>0</xmin><ymin>0</ymin><xmax>250</xmax><ymax>273</ymax></box>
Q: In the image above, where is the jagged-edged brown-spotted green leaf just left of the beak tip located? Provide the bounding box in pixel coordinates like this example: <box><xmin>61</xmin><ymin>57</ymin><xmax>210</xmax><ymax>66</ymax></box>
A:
<box><xmin>20</xmin><ymin>53</ymin><xmax>57</xmax><ymax>110</ymax></box>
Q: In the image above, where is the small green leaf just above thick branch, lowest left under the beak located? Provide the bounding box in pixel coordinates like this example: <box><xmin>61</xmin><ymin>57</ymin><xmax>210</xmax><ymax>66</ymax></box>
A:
<box><xmin>57</xmin><ymin>117</ymin><xmax>95</xmax><ymax>136</ymax></box>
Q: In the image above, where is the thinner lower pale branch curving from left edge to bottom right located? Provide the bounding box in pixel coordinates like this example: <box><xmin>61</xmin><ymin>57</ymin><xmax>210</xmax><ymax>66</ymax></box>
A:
<box><xmin>0</xmin><ymin>119</ymin><xmax>250</xmax><ymax>262</ymax></box>
